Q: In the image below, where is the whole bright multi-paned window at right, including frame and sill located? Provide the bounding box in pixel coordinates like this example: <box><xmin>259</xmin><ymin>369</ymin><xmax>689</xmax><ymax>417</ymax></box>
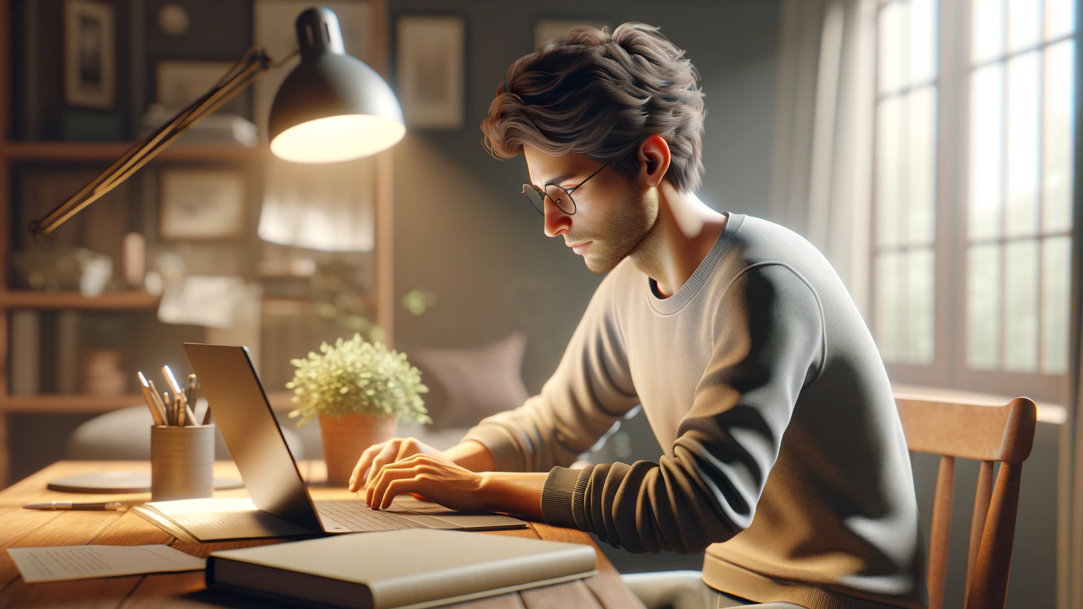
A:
<box><xmin>870</xmin><ymin>0</ymin><xmax>1077</xmax><ymax>401</ymax></box>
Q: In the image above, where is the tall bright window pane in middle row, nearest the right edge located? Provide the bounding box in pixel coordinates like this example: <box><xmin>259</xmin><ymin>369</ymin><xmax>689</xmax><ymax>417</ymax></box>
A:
<box><xmin>1042</xmin><ymin>40</ymin><xmax>1075</xmax><ymax>232</ymax></box>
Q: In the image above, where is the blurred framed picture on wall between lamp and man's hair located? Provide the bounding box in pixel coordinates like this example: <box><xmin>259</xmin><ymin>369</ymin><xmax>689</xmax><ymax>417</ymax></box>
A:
<box><xmin>395</xmin><ymin>15</ymin><xmax>466</xmax><ymax>129</ymax></box>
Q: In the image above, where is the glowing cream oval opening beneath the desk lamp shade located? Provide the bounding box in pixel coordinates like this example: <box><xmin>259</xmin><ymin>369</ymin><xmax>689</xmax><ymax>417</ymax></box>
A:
<box><xmin>271</xmin><ymin>115</ymin><xmax>406</xmax><ymax>163</ymax></box>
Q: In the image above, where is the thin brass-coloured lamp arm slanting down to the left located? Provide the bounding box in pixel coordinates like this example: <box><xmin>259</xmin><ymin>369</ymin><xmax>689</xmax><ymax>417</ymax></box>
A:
<box><xmin>29</xmin><ymin>47</ymin><xmax>272</xmax><ymax>238</ymax></box>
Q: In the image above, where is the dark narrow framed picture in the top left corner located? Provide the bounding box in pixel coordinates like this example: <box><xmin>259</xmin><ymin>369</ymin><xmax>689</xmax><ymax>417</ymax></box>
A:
<box><xmin>64</xmin><ymin>0</ymin><xmax>117</xmax><ymax>108</ymax></box>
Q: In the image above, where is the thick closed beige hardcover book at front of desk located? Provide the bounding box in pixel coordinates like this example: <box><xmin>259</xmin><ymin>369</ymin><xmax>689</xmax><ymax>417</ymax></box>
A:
<box><xmin>206</xmin><ymin>529</ymin><xmax>596</xmax><ymax>609</ymax></box>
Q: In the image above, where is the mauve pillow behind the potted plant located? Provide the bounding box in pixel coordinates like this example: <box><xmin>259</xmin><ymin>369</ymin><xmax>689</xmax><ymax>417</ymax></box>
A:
<box><xmin>410</xmin><ymin>333</ymin><xmax>529</xmax><ymax>429</ymax></box>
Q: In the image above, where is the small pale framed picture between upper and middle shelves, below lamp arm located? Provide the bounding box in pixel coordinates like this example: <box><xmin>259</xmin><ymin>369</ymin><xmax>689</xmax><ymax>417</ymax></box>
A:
<box><xmin>158</xmin><ymin>168</ymin><xmax>248</xmax><ymax>241</ymax></box>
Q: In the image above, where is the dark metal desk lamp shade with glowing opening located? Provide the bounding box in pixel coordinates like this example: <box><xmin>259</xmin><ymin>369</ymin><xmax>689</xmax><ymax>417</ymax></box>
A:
<box><xmin>268</xmin><ymin>8</ymin><xmax>406</xmax><ymax>163</ymax></box>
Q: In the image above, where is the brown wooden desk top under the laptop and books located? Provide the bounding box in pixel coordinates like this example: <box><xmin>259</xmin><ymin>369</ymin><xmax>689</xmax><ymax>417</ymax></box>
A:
<box><xmin>0</xmin><ymin>462</ymin><xmax>642</xmax><ymax>609</ymax></box>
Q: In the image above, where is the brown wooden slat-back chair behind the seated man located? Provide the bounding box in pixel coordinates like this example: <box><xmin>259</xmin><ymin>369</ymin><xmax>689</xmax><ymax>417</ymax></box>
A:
<box><xmin>896</xmin><ymin>396</ymin><xmax>1038</xmax><ymax>609</ymax></box>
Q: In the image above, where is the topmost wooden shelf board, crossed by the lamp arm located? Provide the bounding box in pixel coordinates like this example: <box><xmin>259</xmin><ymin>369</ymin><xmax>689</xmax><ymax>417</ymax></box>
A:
<box><xmin>0</xmin><ymin>141</ymin><xmax>266</xmax><ymax>161</ymax></box>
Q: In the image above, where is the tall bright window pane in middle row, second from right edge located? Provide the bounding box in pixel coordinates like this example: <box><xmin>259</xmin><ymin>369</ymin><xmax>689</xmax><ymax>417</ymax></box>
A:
<box><xmin>1006</xmin><ymin>52</ymin><xmax>1042</xmax><ymax>235</ymax></box>
